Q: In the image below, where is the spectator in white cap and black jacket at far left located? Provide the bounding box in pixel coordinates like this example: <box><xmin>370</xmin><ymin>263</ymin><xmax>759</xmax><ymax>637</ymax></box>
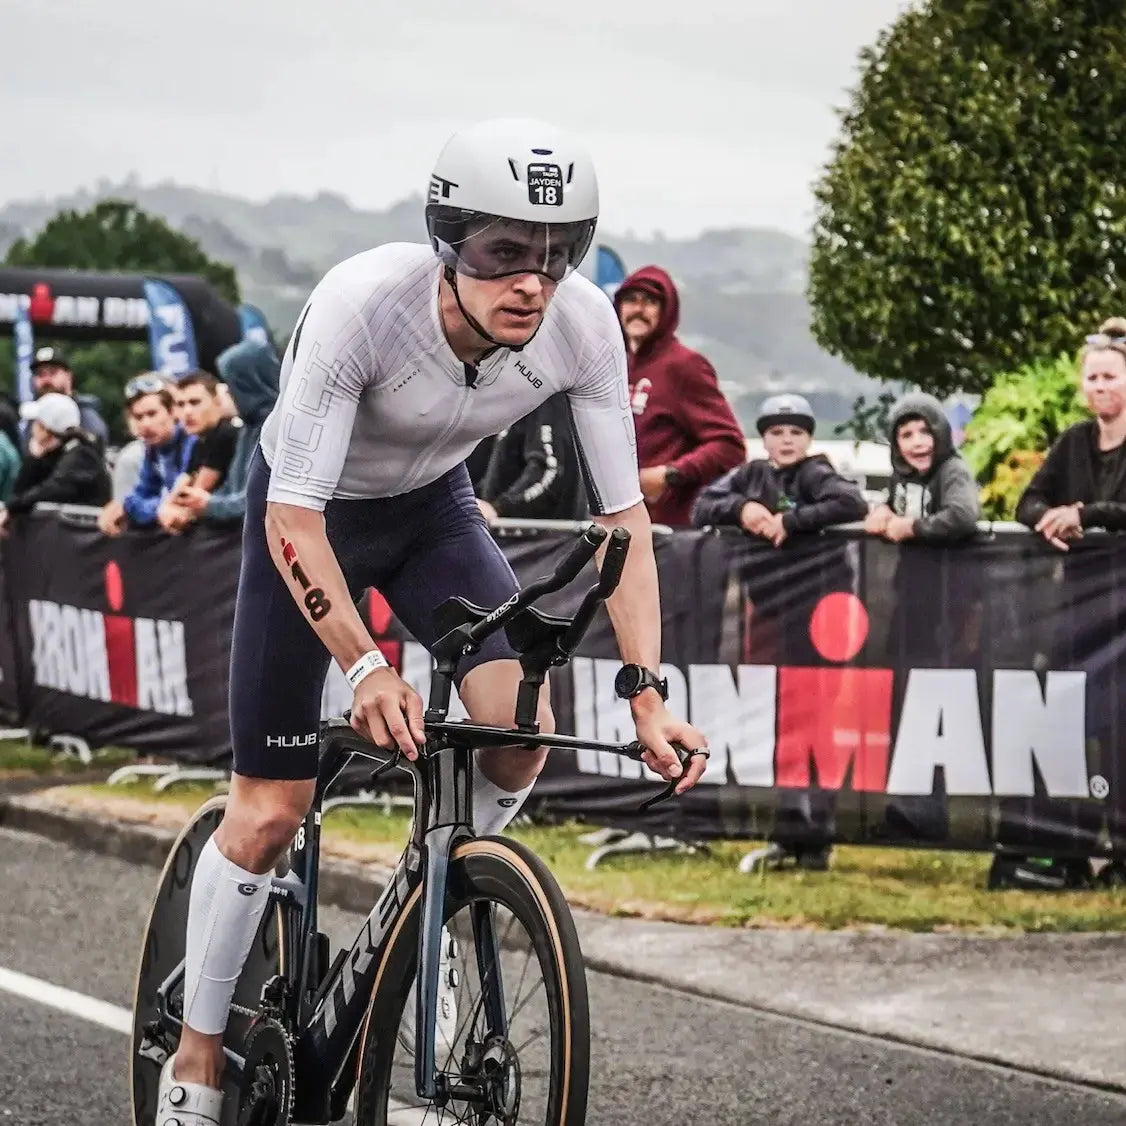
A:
<box><xmin>0</xmin><ymin>391</ymin><xmax>110</xmax><ymax>528</ymax></box>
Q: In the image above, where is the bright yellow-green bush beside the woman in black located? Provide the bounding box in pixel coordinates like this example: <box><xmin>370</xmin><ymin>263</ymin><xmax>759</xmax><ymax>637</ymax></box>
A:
<box><xmin>962</xmin><ymin>354</ymin><xmax>1089</xmax><ymax>520</ymax></box>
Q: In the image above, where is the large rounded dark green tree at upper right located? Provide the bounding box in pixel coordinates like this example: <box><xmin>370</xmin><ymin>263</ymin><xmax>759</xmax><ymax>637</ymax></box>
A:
<box><xmin>808</xmin><ymin>0</ymin><xmax>1126</xmax><ymax>394</ymax></box>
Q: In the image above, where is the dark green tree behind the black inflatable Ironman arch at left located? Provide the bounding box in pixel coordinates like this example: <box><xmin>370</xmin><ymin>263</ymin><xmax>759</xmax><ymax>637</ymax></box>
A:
<box><xmin>0</xmin><ymin>199</ymin><xmax>239</xmax><ymax>439</ymax></box>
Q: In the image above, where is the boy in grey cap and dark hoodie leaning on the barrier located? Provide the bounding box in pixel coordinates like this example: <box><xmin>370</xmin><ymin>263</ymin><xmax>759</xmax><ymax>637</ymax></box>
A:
<box><xmin>692</xmin><ymin>395</ymin><xmax>866</xmax><ymax>538</ymax></box>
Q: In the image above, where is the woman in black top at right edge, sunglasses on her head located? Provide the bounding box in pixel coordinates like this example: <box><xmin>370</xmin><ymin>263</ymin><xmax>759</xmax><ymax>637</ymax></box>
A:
<box><xmin>1017</xmin><ymin>316</ymin><xmax>1126</xmax><ymax>552</ymax></box>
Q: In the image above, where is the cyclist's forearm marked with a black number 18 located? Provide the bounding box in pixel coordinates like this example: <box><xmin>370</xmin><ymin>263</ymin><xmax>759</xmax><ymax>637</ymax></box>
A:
<box><xmin>266</xmin><ymin>504</ymin><xmax>376</xmax><ymax>671</ymax></box>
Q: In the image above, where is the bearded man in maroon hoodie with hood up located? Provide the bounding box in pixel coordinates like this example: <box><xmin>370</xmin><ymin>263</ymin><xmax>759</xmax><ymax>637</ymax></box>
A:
<box><xmin>614</xmin><ymin>266</ymin><xmax>747</xmax><ymax>527</ymax></box>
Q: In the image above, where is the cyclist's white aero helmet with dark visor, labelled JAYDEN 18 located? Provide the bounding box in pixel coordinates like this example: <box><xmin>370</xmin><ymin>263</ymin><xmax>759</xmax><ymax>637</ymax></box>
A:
<box><xmin>426</xmin><ymin>117</ymin><xmax>598</xmax><ymax>282</ymax></box>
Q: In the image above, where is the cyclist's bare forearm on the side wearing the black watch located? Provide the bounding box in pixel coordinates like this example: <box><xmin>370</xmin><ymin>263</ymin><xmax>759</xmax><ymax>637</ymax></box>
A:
<box><xmin>595</xmin><ymin>503</ymin><xmax>661</xmax><ymax>713</ymax></box>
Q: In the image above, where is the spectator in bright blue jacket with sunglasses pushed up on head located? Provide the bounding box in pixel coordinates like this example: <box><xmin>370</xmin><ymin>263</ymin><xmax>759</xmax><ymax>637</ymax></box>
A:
<box><xmin>98</xmin><ymin>372</ymin><xmax>196</xmax><ymax>536</ymax></box>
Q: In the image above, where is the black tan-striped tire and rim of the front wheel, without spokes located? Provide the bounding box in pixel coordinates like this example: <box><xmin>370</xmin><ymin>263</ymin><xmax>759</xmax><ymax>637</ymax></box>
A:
<box><xmin>355</xmin><ymin>837</ymin><xmax>590</xmax><ymax>1126</ymax></box>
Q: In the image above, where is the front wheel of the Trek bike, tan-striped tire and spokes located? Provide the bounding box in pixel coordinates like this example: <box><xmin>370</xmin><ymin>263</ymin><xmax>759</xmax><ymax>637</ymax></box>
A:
<box><xmin>355</xmin><ymin>838</ymin><xmax>590</xmax><ymax>1126</ymax></box>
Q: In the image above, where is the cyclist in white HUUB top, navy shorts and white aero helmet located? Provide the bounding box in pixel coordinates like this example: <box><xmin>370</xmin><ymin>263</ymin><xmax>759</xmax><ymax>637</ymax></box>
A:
<box><xmin>157</xmin><ymin>119</ymin><xmax>705</xmax><ymax>1126</ymax></box>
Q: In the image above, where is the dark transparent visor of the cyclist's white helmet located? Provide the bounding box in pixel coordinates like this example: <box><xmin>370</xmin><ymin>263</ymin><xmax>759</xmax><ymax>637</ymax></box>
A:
<box><xmin>427</xmin><ymin>208</ymin><xmax>597</xmax><ymax>282</ymax></box>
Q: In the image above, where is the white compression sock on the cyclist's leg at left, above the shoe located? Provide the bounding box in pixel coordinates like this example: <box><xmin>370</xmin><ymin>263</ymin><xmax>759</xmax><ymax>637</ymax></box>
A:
<box><xmin>184</xmin><ymin>837</ymin><xmax>270</xmax><ymax>1035</ymax></box>
